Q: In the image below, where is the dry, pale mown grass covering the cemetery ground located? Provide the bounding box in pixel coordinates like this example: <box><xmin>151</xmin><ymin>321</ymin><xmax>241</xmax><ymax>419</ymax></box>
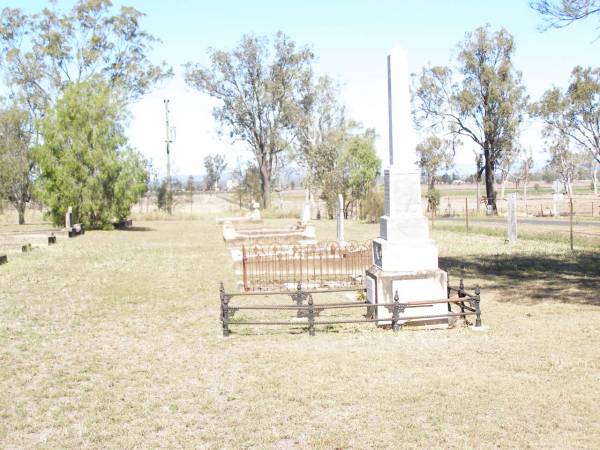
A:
<box><xmin>0</xmin><ymin>218</ymin><xmax>600</xmax><ymax>449</ymax></box>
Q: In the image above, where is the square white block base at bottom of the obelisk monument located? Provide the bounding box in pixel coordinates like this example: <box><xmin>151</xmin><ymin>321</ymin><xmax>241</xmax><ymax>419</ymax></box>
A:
<box><xmin>366</xmin><ymin>266</ymin><xmax>448</xmax><ymax>328</ymax></box>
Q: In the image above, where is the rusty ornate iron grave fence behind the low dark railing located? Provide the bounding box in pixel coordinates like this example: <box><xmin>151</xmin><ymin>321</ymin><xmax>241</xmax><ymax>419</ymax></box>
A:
<box><xmin>242</xmin><ymin>241</ymin><xmax>373</xmax><ymax>292</ymax></box>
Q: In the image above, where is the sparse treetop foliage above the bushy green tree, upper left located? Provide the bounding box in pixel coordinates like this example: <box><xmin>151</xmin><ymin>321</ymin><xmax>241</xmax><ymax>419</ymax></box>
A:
<box><xmin>0</xmin><ymin>0</ymin><xmax>172</xmax><ymax>111</ymax></box>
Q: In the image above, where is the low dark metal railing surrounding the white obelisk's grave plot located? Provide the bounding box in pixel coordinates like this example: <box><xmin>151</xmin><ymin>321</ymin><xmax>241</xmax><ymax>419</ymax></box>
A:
<box><xmin>220</xmin><ymin>280</ymin><xmax>481</xmax><ymax>337</ymax></box>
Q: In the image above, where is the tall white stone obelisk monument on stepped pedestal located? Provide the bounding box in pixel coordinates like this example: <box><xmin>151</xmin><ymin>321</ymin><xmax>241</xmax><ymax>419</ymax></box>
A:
<box><xmin>367</xmin><ymin>46</ymin><xmax>447</xmax><ymax>323</ymax></box>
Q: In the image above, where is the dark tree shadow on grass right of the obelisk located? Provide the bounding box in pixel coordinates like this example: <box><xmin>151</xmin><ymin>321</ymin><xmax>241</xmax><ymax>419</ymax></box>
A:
<box><xmin>440</xmin><ymin>252</ymin><xmax>600</xmax><ymax>306</ymax></box>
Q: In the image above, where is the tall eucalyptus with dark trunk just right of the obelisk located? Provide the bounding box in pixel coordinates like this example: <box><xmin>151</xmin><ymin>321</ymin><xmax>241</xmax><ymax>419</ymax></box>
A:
<box><xmin>413</xmin><ymin>26</ymin><xmax>527</xmax><ymax>211</ymax></box>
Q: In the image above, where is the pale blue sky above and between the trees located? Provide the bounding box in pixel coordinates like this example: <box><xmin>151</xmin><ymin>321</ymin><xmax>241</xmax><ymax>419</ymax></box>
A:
<box><xmin>11</xmin><ymin>0</ymin><xmax>600</xmax><ymax>177</ymax></box>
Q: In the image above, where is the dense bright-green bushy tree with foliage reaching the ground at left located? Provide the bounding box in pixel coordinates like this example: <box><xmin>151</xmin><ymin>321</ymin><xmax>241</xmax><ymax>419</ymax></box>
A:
<box><xmin>34</xmin><ymin>80</ymin><xmax>148</xmax><ymax>228</ymax></box>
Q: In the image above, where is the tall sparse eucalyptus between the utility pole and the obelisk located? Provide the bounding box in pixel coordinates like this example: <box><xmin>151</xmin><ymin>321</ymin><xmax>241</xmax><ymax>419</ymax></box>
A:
<box><xmin>185</xmin><ymin>32</ymin><xmax>314</xmax><ymax>208</ymax></box>
